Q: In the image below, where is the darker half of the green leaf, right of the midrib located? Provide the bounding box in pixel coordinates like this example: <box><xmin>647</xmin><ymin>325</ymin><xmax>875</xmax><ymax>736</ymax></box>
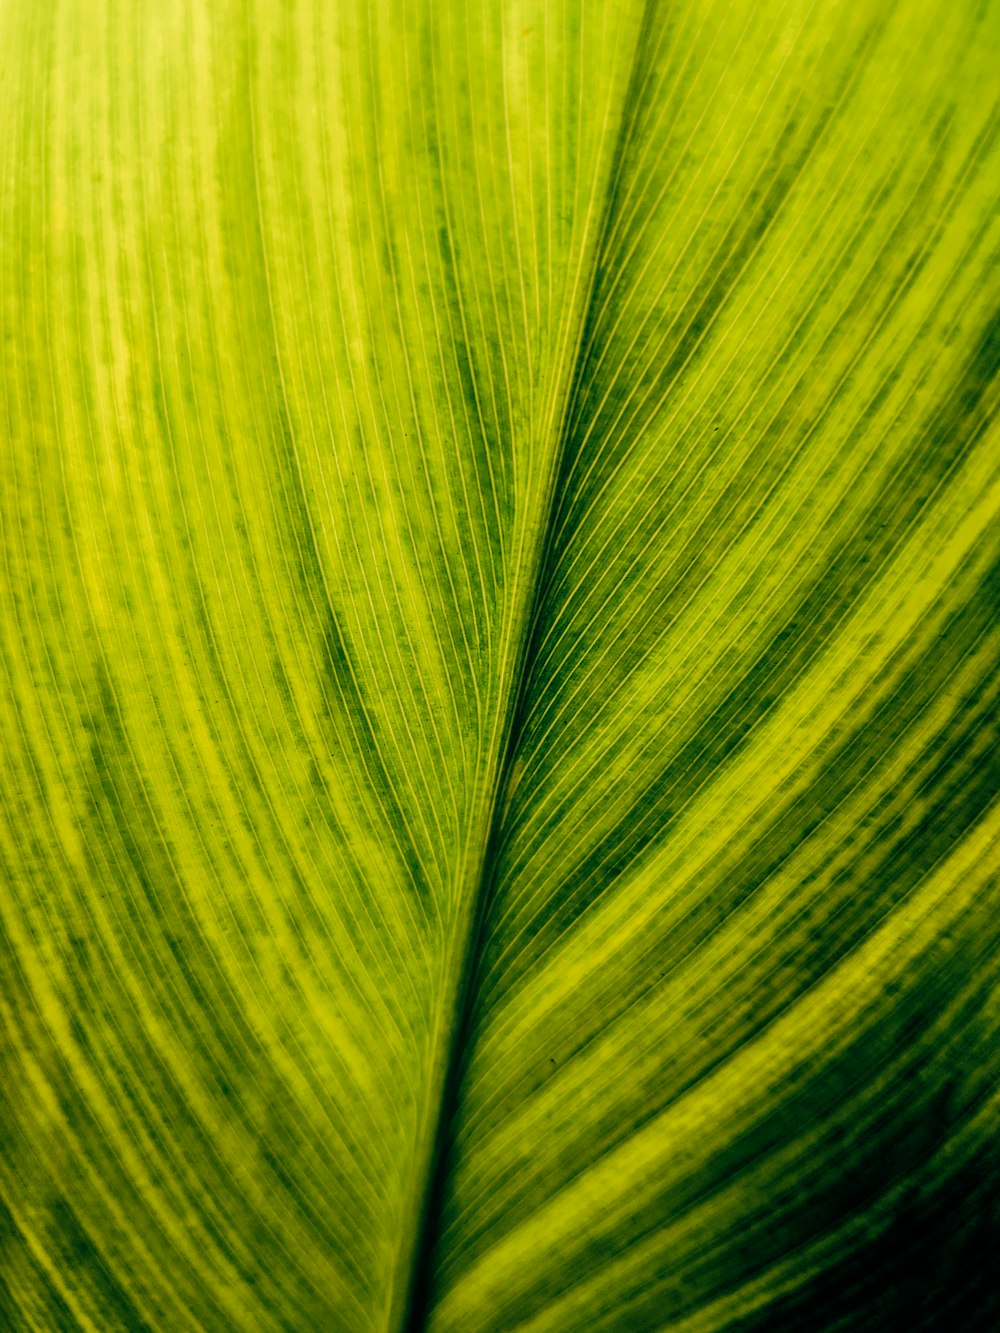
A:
<box><xmin>431</xmin><ymin>5</ymin><xmax>1000</xmax><ymax>1330</ymax></box>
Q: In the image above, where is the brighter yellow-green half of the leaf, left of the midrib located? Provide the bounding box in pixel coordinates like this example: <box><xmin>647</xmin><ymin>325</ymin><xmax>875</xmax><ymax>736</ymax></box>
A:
<box><xmin>0</xmin><ymin>0</ymin><xmax>636</xmax><ymax>1333</ymax></box>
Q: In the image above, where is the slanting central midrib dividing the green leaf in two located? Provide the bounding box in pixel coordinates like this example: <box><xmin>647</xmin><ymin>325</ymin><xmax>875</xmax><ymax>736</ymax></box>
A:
<box><xmin>385</xmin><ymin>15</ymin><xmax>652</xmax><ymax>1333</ymax></box>
